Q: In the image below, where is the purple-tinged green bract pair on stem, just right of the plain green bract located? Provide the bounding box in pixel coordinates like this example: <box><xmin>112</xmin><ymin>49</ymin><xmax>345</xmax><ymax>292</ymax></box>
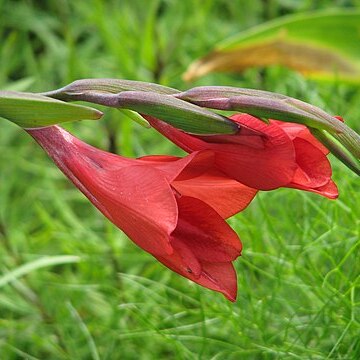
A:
<box><xmin>43</xmin><ymin>79</ymin><xmax>239</xmax><ymax>135</ymax></box>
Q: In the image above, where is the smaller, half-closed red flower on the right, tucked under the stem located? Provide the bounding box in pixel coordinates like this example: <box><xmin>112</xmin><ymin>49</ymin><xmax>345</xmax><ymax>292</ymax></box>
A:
<box><xmin>146</xmin><ymin>114</ymin><xmax>338</xmax><ymax>199</ymax></box>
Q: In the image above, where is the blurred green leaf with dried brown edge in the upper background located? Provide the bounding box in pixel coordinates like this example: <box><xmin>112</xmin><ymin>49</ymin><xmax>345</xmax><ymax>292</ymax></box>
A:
<box><xmin>184</xmin><ymin>9</ymin><xmax>360</xmax><ymax>82</ymax></box>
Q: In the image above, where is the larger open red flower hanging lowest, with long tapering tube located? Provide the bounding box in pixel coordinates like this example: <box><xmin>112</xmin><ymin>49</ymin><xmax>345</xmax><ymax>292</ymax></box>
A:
<box><xmin>28</xmin><ymin>126</ymin><xmax>256</xmax><ymax>301</ymax></box>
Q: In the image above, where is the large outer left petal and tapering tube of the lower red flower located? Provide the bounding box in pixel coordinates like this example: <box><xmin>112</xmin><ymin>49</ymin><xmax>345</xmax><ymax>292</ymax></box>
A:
<box><xmin>29</xmin><ymin>127</ymin><xmax>177</xmax><ymax>255</ymax></box>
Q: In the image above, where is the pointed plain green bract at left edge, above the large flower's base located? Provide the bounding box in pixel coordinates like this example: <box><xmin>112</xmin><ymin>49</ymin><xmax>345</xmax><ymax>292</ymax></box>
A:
<box><xmin>0</xmin><ymin>91</ymin><xmax>102</xmax><ymax>128</ymax></box>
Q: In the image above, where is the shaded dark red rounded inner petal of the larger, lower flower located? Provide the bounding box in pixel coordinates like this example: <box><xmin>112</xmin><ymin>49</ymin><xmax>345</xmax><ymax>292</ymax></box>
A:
<box><xmin>172</xmin><ymin>196</ymin><xmax>241</xmax><ymax>262</ymax></box>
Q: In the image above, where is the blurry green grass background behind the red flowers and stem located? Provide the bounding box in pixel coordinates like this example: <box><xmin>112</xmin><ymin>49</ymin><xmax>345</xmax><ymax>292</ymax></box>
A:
<box><xmin>0</xmin><ymin>0</ymin><xmax>360</xmax><ymax>360</ymax></box>
